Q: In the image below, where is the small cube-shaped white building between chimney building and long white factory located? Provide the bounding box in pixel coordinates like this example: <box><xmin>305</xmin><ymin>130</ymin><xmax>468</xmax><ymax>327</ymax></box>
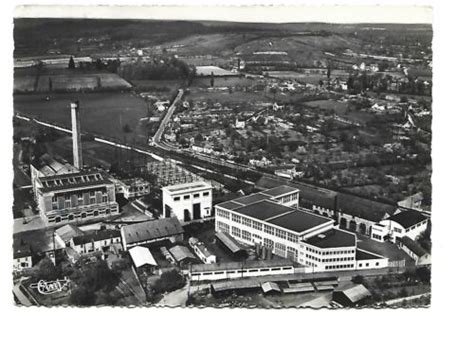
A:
<box><xmin>162</xmin><ymin>181</ymin><xmax>212</xmax><ymax>221</ymax></box>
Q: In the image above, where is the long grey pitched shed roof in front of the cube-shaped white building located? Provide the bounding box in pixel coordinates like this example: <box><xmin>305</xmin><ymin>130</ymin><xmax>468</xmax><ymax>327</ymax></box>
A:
<box><xmin>122</xmin><ymin>217</ymin><xmax>184</xmax><ymax>244</ymax></box>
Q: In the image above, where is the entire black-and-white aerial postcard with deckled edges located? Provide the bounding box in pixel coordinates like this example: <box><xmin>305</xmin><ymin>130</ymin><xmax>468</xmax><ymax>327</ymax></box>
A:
<box><xmin>8</xmin><ymin>6</ymin><xmax>440</xmax><ymax>309</ymax></box>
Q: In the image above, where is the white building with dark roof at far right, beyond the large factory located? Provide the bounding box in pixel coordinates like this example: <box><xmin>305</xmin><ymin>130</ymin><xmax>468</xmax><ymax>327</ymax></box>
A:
<box><xmin>371</xmin><ymin>210</ymin><xmax>429</xmax><ymax>243</ymax></box>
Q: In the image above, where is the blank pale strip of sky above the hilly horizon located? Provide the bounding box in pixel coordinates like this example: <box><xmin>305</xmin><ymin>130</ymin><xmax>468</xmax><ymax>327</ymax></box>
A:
<box><xmin>14</xmin><ymin>5</ymin><xmax>432</xmax><ymax>23</ymax></box>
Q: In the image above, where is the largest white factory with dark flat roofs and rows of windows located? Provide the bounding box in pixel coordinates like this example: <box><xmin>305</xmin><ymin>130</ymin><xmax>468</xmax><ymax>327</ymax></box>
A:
<box><xmin>215</xmin><ymin>186</ymin><xmax>387</xmax><ymax>272</ymax></box>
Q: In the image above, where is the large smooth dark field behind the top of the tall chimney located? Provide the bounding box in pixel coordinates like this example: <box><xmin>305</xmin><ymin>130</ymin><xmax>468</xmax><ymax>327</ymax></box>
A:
<box><xmin>13</xmin><ymin>92</ymin><xmax>147</xmax><ymax>144</ymax></box>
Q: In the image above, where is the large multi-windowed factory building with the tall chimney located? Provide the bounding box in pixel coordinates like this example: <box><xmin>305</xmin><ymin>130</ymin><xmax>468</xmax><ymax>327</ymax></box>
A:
<box><xmin>31</xmin><ymin>102</ymin><xmax>119</xmax><ymax>226</ymax></box>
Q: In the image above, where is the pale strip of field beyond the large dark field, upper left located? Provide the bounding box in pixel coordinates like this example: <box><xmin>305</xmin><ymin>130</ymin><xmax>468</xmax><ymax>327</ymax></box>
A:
<box><xmin>13</xmin><ymin>73</ymin><xmax>131</xmax><ymax>93</ymax></box>
